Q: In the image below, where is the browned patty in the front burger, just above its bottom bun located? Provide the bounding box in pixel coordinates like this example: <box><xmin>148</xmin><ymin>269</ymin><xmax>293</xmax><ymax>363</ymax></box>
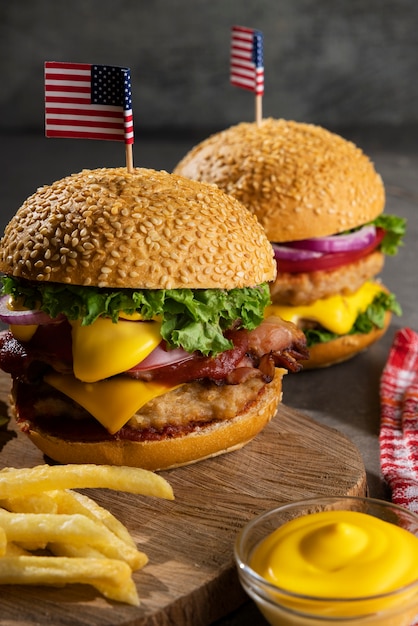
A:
<box><xmin>13</xmin><ymin>369</ymin><xmax>286</xmax><ymax>440</ymax></box>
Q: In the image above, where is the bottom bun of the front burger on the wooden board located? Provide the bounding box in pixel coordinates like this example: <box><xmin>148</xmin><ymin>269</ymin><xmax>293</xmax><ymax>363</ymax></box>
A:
<box><xmin>17</xmin><ymin>369</ymin><xmax>286</xmax><ymax>471</ymax></box>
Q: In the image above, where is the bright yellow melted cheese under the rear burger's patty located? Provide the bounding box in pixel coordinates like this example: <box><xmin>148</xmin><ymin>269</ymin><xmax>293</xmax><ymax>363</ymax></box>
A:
<box><xmin>265</xmin><ymin>282</ymin><xmax>382</xmax><ymax>335</ymax></box>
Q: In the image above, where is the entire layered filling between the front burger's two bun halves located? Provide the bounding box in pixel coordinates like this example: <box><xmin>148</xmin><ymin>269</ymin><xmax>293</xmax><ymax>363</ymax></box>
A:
<box><xmin>0</xmin><ymin>277</ymin><xmax>307</xmax><ymax>439</ymax></box>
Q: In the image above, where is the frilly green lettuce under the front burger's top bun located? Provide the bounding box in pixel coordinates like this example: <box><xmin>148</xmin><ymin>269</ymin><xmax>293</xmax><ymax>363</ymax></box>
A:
<box><xmin>2</xmin><ymin>276</ymin><xmax>270</xmax><ymax>356</ymax></box>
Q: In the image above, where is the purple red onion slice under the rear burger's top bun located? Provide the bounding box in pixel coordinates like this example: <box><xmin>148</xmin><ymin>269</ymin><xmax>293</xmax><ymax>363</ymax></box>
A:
<box><xmin>286</xmin><ymin>224</ymin><xmax>376</xmax><ymax>252</ymax></box>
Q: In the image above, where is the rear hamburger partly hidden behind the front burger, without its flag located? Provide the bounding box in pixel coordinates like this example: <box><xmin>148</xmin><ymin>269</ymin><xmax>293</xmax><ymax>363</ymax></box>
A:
<box><xmin>175</xmin><ymin>118</ymin><xmax>405</xmax><ymax>369</ymax></box>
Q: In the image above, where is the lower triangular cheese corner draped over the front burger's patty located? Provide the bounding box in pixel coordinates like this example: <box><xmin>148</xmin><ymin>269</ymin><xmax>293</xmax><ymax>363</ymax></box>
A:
<box><xmin>44</xmin><ymin>372</ymin><xmax>179</xmax><ymax>434</ymax></box>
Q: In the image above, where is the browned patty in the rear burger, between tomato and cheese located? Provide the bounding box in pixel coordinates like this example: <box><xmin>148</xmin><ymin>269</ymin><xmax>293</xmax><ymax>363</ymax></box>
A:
<box><xmin>270</xmin><ymin>251</ymin><xmax>384</xmax><ymax>306</ymax></box>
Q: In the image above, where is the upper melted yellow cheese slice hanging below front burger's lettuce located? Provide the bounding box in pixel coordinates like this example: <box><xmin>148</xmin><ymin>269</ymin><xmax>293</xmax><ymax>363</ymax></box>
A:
<box><xmin>71</xmin><ymin>318</ymin><xmax>161</xmax><ymax>383</ymax></box>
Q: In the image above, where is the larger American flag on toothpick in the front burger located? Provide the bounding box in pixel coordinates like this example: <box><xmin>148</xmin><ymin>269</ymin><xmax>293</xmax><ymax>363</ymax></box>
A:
<box><xmin>45</xmin><ymin>61</ymin><xmax>134</xmax><ymax>144</ymax></box>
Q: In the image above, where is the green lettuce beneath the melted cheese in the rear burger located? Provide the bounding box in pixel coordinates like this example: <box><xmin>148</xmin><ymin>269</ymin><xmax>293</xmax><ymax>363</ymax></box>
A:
<box><xmin>304</xmin><ymin>291</ymin><xmax>402</xmax><ymax>348</ymax></box>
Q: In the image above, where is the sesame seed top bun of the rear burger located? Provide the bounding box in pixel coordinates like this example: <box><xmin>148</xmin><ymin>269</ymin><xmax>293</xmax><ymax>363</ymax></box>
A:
<box><xmin>174</xmin><ymin>118</ymin><xmax>385</xmax><ymax>242</ymax></box>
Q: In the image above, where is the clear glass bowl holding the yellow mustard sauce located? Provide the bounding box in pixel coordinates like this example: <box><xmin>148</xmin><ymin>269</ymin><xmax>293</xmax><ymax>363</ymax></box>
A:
<box><xmin>234</xmin><ymin>496</ymin><xmax>418</xmax><ymax>626</ymax></box>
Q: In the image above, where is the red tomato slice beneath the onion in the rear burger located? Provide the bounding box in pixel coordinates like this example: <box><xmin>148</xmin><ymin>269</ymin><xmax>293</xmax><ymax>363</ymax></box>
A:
<box><xmin>277</xmin><ymin>228</ymin><xmax>385</xmax><ymax>274</ymax></box>
